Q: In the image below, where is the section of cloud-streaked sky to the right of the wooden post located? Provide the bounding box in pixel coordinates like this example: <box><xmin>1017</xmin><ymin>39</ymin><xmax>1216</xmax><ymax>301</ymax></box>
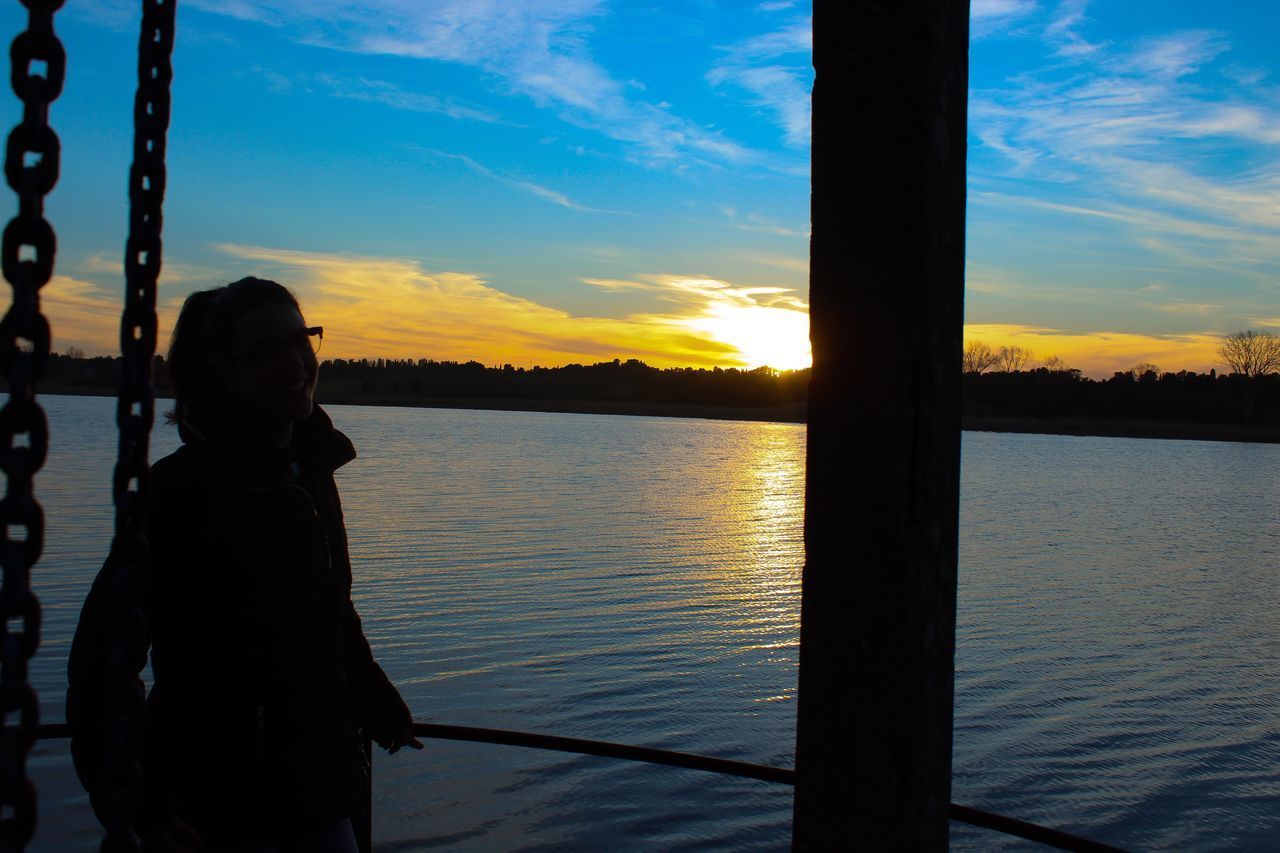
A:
<box><xmin>966</xmin><ymin>0</ymin><xmax>1280</xmax><ymax>373</ymax></box>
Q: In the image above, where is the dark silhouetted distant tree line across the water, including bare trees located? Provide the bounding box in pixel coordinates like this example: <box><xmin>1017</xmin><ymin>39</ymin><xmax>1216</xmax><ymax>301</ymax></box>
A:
<box><xmin>27</xmin><ymin>330</ymin><xmax>1280</xmax><ymax>427</ymax></box>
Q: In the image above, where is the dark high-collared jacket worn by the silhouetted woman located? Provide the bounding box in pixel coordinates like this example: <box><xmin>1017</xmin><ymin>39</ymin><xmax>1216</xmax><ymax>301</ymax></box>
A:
<box><xmin>67</xmin><ymin>407</ymin><xmax>411</xmax><ymax>843</ymax></box>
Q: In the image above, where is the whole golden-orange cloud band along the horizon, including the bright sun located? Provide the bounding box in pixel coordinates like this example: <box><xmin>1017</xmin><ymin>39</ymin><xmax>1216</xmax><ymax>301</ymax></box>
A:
<box><xmin>41</xmin><ymin>263</ymin><xmax>1228</xmax><ymax>378</ymax></box>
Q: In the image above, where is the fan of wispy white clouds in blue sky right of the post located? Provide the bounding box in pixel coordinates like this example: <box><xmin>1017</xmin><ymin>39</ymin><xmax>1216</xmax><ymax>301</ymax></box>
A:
<box><xmin>970</xmin><ymin>21</ymin><xmax>1280</xmax><ymax>213</ymax></box>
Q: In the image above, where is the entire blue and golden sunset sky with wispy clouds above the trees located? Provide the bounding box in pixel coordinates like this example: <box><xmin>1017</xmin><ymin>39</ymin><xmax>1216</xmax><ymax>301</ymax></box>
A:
<box><xmin>0</xmin><ymin>0</ymin><xmax>1280</xmax><ymax>377</ymax></box>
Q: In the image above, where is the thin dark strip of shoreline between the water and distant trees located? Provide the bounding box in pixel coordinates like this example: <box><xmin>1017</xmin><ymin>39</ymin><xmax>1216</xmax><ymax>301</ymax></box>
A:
<box><xmin>24</xmin><ymin>387</ymin><xmax>1280</xmax><ymax>444</ymax></box>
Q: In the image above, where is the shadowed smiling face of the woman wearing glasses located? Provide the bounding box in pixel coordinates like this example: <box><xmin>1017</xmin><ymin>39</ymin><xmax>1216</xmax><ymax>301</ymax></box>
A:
<box><xmin>221</xmin><ymin>304</ymin><xmax>320</xmax><ymax>427</ymax></box>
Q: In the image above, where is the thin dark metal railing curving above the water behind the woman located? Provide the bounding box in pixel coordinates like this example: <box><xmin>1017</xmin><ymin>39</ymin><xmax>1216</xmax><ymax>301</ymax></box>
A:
<box><xmin>37</xmin><ymin>722</ymin><xmax>1120</xmax><ymax>853</ymax></box>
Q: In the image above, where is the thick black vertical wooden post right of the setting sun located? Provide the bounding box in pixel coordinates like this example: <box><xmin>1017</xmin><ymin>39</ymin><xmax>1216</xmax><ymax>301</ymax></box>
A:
<box><xmin>794</xmin><ymin>0</ymin><xmax>969</xmax><ymax>850</ymax></box>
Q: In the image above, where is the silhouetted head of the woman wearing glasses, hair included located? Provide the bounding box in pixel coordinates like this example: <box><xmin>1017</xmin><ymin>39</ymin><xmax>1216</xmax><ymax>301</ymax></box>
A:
<box><xmin>169</xmin><ymin>278</ymin><xmax>319</xmax><ymax>428</ymax></box>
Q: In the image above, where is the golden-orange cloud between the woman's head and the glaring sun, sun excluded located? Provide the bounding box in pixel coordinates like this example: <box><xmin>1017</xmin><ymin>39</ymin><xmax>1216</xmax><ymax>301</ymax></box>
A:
<box><xmin>219</xmin><ymin>245</ymin><xmax>808</xmax><ymax>366</ymax></box>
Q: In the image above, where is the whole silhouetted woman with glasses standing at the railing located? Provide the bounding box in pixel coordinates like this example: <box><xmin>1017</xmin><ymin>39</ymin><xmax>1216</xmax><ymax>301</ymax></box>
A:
<box><xmin>67</xmin><ymin>278</ymin><xmax>421</xmax><ymax>852</ymax></box>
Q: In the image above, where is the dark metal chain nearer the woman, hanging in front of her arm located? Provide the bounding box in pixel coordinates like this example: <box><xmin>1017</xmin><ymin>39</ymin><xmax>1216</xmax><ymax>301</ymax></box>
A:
<box><xmin>101</xmin><ymin>0</ymin><xmax>177</xmax><ymax>850</ymax></box>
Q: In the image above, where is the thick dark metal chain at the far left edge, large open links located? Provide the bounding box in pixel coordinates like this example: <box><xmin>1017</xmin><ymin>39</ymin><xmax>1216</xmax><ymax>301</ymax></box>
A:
<box><xmin>0</xmin><ymin>0</ymin><xmax>67</xmax><ymax>850</ymax></box>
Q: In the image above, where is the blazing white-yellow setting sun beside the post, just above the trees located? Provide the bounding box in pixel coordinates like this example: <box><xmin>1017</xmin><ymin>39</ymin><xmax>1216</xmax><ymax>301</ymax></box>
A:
<box><xmin>684</xmin><ymin>305</ymin><xmax>813</xmax><ymax>370</ymax></box>
